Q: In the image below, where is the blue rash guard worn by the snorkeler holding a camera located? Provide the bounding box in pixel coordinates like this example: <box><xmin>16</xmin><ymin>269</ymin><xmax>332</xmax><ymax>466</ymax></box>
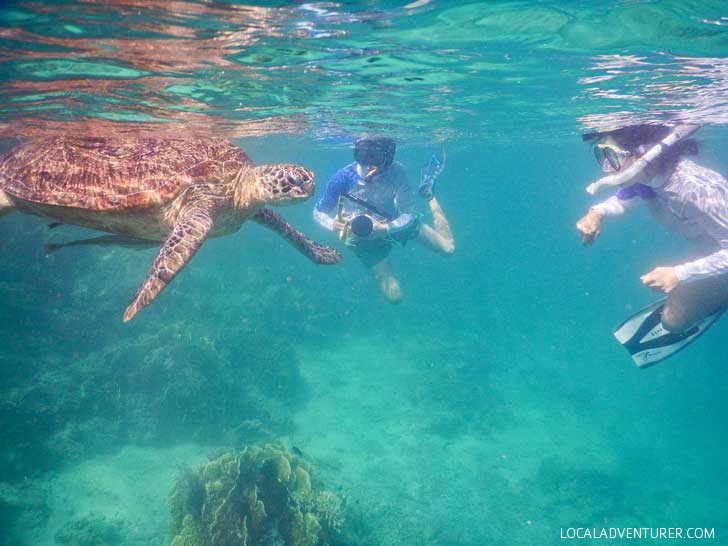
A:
<box><xmin>313</xmin><ymin>161</ymin><xmax>417</xmax><ymax>233</ymax></box>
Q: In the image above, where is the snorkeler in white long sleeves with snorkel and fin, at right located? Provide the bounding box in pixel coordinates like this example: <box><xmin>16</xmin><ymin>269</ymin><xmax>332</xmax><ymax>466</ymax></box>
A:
<box><xmin>576</xmin><ymin>125</ymin><xmax>728</xmax><ymax>367</ymax></box>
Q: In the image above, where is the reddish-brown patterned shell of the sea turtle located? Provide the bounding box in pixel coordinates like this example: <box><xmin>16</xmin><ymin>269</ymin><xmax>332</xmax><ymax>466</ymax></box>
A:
<box><xmin>0</xmin><ymin>137</ymin><xmax>253</xmax><ymax>210</ymax></box>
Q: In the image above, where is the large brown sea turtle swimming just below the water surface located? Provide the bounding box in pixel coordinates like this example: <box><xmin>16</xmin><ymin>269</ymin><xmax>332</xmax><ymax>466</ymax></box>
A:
<box><xmin>0</xmin><ymin>136</ymin><xmax>341</xmax><ymax>322</ymax></box>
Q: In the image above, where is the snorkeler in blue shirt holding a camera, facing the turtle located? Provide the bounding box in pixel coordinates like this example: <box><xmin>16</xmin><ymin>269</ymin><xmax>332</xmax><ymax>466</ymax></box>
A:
<box><xmin>313</xmin><ymin>137</ymin><xmax>455</xmax><ymax>303</ymax></box>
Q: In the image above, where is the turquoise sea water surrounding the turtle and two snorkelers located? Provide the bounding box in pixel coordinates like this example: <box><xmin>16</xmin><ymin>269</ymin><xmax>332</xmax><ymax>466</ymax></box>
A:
<box><xmin>0</xmin><ymin>0</ymin><xmax>728</xmax><ymax>546</ymax></box>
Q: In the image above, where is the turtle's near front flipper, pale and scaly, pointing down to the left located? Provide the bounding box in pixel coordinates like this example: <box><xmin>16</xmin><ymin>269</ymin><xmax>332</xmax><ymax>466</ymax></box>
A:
<box><xmin>124</xmin><ymin>202</ymin><xmax>214</xmax><ymax>322</ymax></box>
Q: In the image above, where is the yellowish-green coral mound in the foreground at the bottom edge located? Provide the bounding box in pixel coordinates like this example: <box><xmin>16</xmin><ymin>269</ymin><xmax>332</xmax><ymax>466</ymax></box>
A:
<box><xmin>170</xmin><ymin>444</ymin><xmax>344</xmax><ymax>546</ymax></box>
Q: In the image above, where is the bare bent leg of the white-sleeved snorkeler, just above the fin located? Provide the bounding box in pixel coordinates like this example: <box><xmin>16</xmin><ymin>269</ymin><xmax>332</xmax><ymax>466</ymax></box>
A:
<box><xmin>662</xmin><ymin>274</ymin><xmax>728</xmax><ymax>332</ymax></box>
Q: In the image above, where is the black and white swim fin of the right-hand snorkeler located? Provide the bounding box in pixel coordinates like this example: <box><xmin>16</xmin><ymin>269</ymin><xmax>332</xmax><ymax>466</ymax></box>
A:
<box><xmin>614</xmin><ymin>299</ymin><xmax>726</xmax><ymax>368</ymax></box>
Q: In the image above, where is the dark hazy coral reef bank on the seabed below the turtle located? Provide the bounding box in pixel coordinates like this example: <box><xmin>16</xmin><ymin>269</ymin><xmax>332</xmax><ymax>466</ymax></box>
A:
<box><xmin>0</xmin><ymin>314</ymin><xmax>301</xmax><ymax>482</ymax></box>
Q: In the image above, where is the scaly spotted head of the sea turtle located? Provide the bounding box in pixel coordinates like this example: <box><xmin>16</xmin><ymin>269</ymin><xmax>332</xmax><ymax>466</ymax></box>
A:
<box><xmin>235</xmin><ymin>163</ymin><xmax>314</xmax><ymax>208</ymax></box>
